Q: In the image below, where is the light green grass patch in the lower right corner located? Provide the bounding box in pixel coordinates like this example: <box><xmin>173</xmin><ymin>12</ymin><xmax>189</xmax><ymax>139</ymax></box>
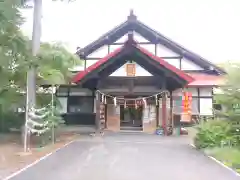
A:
<box><xmin>205</xmin><ymin>147</ymin><xmax>240</xmax><ymax>173</ymax></box>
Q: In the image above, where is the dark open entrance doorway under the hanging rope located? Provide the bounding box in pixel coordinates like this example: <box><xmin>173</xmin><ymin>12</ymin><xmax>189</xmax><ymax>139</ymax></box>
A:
<box><xmin>120</xmin><ymin>105</ymin><xmax>143</xmax><ymax>130</ymax></box>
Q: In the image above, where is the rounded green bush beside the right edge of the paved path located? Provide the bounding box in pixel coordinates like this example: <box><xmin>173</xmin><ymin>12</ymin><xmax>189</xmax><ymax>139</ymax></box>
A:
<box><xmin>194</xmin><ymin>120</ymin><xmax>231</xmax><ymax>149</ymax></box>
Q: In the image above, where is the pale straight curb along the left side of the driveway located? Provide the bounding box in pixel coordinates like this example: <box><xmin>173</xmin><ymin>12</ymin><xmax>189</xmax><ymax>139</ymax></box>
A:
<box><xmin>3</xmin><ymin>140</ymin><xmax>76</xmax><ymax>180</ymax></box>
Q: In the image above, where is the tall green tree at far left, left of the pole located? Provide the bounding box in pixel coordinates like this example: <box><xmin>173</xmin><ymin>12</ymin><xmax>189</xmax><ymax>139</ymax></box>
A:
<box><xmin>0</xmin><ymin>0</ymin><xmax>32</xmax><ymax>107</ymax></box>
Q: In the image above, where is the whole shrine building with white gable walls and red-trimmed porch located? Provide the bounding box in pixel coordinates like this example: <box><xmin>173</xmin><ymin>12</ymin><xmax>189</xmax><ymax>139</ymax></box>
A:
<box><xmin>56</xmin><ymin>11</ymin><xmax>225</xmax><ymax>133</ymax></box>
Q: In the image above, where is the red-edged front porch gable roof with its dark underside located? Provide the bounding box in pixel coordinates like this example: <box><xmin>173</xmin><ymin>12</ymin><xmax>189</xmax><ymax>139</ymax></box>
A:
<box><xmin>72</xmin><ymin>40</ymin><xmax>194</xmax><ymax>89</ymax></box>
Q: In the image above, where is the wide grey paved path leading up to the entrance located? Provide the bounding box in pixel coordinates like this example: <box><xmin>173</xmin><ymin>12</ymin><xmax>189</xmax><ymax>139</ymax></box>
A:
<box><xmin>6</xmin><ymin>135</ymin><xmax>240</xmax><ymax>180</ymax></box>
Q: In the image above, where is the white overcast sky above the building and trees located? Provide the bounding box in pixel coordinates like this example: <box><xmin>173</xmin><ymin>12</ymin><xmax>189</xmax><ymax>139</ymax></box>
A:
<box><xmin>22</xmin><ymin>0</ymin><xmax>240</xmax><ymax>62</ymax></box>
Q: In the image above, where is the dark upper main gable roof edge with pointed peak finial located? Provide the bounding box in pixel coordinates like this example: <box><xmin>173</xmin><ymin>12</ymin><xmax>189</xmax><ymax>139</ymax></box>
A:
<box><xmin>77</xmin><ymin>11</ymin><xmax>226</xmax><ymax>74</ymax></box>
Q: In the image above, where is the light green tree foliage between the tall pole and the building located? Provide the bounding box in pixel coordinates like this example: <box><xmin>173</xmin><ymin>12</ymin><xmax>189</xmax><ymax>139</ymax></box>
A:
<box><xmin>37</xmin><ymin>43</ymin><xmax>81</xmax><ymax>85</ymax></box>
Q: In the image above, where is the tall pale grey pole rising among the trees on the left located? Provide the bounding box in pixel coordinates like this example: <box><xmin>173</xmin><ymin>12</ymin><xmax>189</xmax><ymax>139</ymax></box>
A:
<box><xmin>24</xmin><ymin>0</ymin><xmax>42</xmax><ymax>152</ymax></box>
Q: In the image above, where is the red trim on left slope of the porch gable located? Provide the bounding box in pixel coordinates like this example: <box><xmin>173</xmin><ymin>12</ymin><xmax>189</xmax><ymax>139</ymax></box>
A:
<box><xmin>72</xmin><ymin>46</ymin><xmax>123</xmax><ymax>83</ymax></box>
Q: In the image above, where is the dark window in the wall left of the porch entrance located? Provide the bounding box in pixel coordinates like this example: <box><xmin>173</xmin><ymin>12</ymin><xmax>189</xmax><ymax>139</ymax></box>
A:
<box><xmin>68</xmin><ymin>96</ymin><xmax>94</xmax><ymax>113</ymax></box>
